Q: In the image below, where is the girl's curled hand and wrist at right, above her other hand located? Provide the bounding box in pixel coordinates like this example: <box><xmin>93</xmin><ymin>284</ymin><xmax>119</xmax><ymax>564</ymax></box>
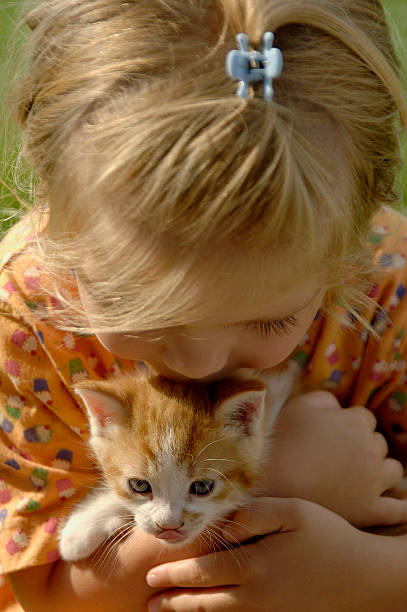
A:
<box><xmin>261</xmin><ymin>391</ymin><xmax>407</xmax><ymax>527</ymax></box>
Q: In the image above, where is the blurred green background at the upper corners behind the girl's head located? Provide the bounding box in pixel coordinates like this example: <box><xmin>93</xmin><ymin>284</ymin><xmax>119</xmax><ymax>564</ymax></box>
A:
<box><xmin>0</xmin><ymin>0</ymin><xmax>407</xmax><ymax>234</ymax></box>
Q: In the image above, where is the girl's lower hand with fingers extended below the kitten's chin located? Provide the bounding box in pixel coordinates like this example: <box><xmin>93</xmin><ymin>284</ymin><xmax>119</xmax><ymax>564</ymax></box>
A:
<box><xmin>147</xmin><ymin>498</ymin><xmax>407</xmax><ymax>612</ymax></box>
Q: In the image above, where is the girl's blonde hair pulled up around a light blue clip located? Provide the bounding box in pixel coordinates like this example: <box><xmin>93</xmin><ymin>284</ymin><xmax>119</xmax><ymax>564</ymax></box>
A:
<box><xmin>5</xmin><ymin>0</ymin><xmax>407</xmax><ymax>331</ymax></box>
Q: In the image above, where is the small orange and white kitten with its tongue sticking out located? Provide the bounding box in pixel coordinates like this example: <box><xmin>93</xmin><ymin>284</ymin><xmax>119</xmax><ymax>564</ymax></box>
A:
<box><xmin>59</xmin><ymin>368</ymin><xmax>295</xmax><ymax>561</ymax></box>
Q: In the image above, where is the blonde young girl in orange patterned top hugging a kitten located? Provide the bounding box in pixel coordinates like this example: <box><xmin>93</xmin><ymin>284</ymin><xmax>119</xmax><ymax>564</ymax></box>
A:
<box><xmin>0</xmin><ymin>0</ymin><xmax>407</xmax><ymax>612</ymax></box>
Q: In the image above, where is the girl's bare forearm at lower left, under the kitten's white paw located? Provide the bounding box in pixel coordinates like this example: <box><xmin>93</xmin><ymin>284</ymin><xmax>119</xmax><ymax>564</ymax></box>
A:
<box><xmin>9</xmin><ymin>531</ymin><xmax>205</xmax><ymax>612</ymax></box>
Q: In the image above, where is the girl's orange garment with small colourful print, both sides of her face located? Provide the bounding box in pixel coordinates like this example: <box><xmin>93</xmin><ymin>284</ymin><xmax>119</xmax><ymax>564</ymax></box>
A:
<box><xmin>0</xmin><ymin>208</ymin><xmax>407</xmax><ymax>612</ymax></box>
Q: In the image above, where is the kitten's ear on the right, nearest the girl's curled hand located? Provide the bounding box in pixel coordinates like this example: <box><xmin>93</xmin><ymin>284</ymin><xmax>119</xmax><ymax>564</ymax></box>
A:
<box><xmin>218</xmin><ymin>389</ymin><xmax>266</xmax><ymax>436</ymax></box>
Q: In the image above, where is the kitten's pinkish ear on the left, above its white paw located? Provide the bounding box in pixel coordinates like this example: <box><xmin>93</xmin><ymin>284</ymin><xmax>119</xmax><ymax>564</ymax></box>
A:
<box><xmin>75</xmin><ymin>388</ymin><xmax>125</xmax><ymax>435</ymax></box>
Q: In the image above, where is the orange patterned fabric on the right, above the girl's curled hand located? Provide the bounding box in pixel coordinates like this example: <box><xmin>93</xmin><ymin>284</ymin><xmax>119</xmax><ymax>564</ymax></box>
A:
<box><xmin>300</xmin><ymin>208</ymin><xmax>407</xmax><ymax>464</ymax></box>
